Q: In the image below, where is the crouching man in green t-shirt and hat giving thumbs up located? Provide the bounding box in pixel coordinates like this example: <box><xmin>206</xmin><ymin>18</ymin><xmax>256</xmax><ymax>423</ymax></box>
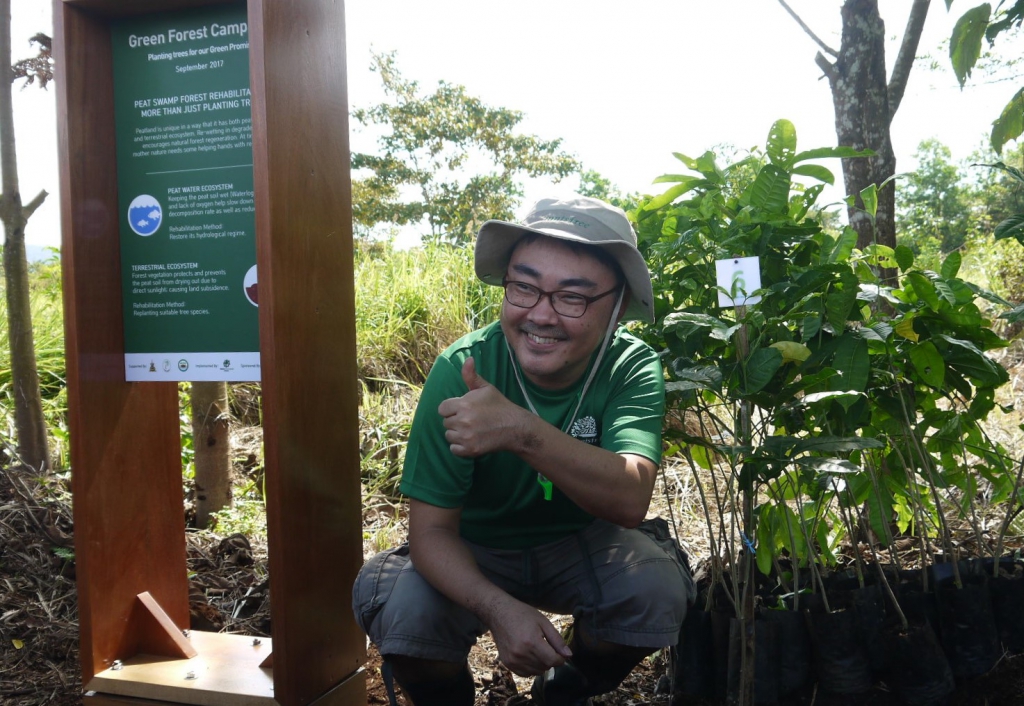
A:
<box><xmin>353</xmin><ymin>198</ymin><xmax>692</xmax><ymax>706</ymax></box>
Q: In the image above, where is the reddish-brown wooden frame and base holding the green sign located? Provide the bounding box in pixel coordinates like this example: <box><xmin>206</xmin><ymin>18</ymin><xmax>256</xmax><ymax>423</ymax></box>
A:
<box><xmin>53</xmin><ymin>0</ymin><xmax>366</xmax><ymax>706</ymax></box>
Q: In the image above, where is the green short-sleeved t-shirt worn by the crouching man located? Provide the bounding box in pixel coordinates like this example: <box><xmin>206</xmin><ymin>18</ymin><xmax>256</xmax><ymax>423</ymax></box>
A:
<box><xmin>400</xmin><ymin>322</ymin><xmax>665</xmax><ymax>549</ymax></box>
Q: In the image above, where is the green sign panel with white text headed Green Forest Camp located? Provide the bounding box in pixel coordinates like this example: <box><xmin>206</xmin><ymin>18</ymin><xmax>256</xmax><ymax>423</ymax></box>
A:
<box><xmin>112</xmin><ymin>4</ymin><xmax>260</xmax><ymax>380</ymax></box>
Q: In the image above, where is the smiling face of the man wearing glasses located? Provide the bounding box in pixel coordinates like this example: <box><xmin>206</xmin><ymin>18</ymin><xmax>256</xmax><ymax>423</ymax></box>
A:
<box><xmin>502</xmin><ymin>238</ymin><xmax>622</xmax><ymax>389</ymax></box>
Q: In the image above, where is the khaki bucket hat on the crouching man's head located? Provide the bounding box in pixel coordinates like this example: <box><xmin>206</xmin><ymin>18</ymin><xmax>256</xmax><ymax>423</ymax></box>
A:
<box><xmin>474</xmin><ymin>196</ymin><xmax>654</xmax><ymax>322</ymax></box>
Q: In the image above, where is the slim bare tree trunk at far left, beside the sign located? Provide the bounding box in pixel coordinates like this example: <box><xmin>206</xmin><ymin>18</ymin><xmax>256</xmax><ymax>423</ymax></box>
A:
<box><xmin>0</xmin><ymin>0</ymin><xmax>50</xmax><ymax>471</ymax></box>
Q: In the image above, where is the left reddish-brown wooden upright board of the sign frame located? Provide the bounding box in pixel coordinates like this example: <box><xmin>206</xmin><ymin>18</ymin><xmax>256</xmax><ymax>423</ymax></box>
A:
<box><xmin>53</xmin><ymin>0</ymin><xmax>188</xmax><ymax>681</ymax></box>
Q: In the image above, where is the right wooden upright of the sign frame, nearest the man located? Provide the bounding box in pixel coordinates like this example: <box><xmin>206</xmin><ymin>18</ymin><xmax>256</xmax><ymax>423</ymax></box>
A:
<box><xmin>249</xmin><ymin>0</ymin><xmax>366</xmax><ymax>704</ymax></box>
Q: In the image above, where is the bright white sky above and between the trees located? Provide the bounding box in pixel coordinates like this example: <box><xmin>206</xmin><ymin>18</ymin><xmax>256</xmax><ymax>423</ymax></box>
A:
<box><xmin>12</xmin><ymin>0</ymin><xmax>1024</xmax><ymax>253</ymax></box>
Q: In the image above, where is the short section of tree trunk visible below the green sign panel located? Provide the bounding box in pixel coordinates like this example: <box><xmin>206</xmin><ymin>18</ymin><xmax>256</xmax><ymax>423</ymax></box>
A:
<box><xmin>191</xmin><ymin>382</ymin><xmax>231</xmax><ymax>529</ymax></box>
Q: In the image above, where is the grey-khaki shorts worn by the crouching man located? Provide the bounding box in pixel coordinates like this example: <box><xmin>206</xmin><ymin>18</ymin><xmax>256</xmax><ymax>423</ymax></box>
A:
<box><xmin>352</xmin><ymin>518</ymin><xmax>694</xmax><ymax>662</ymax></box>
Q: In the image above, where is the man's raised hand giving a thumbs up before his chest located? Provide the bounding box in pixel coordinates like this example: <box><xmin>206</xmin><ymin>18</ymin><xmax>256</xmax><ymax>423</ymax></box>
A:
<box><xmin>437</xmin><ymin>358</ymin><xmax>531</xmax><ymax>458</ymax></box>
